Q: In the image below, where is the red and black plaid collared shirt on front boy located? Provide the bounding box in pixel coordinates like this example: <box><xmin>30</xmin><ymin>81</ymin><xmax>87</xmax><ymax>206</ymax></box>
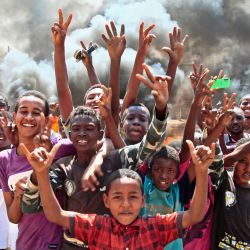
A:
<box><xmin>69</xmin><ymin>213</ymin><xmax>182</xmax><ymax>250</ymax></box>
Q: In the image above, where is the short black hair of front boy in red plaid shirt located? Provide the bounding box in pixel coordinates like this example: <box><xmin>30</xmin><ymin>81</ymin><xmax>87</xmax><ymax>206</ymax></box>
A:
<box><xmin>105</xmin><ymin>168</ymin><xmax>144</xmax><ymax>194</ymax></box>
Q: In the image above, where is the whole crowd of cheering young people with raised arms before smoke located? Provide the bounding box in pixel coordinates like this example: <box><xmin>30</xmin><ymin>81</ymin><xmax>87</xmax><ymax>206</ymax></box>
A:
<box><xmin>0</xmin><ymin>7</ymin><xmax>250</xmax><ymax>250</ymax></box>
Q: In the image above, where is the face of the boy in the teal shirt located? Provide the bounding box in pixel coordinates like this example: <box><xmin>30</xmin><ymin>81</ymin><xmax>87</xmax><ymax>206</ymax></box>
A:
<box><xmin>151</xmin><ymin>158</ymin><xmax>178</xmax><ymax>191</ymax></box>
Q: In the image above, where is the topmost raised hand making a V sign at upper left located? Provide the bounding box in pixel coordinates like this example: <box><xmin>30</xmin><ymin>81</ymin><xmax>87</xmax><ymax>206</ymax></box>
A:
<box><xmin>51</xmin><ymin>9</ymin><xmax>72</xmax><ymax>46</ymax></box>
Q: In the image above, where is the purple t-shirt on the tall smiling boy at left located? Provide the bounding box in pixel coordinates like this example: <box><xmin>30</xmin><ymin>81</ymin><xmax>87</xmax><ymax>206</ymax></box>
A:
<box><xmin>0</xmin><ymin>139</ymin><xmax>75</xmax><ymax>250</ymax></box>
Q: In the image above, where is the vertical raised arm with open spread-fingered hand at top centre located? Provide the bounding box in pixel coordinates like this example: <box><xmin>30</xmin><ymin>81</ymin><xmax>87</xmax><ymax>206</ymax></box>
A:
<box><xmin>102</xmin><ymin>21</ymin><xmax>126</xmax><ymax>127</ymax></box>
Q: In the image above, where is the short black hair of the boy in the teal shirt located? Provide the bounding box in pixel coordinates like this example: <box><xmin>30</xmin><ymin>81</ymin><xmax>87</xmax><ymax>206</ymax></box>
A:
<box><xmin>148</xmin><ymin>146</ymin><xmax>180</xmax><ymax>177</ymax></box>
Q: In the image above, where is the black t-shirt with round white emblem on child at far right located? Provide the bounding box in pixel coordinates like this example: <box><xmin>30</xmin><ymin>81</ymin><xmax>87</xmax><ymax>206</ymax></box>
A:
<box><xmin>211</xmin><ymin>171</ymin><xmax>250</xmax><ymax>250</ymax></box>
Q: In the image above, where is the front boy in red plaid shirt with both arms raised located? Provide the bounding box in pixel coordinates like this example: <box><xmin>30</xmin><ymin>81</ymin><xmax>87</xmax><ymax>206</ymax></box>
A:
<box><xmin>21</xmin><ymin>141</ymin><xmax>215</xmax><ymax>249</ymax></box>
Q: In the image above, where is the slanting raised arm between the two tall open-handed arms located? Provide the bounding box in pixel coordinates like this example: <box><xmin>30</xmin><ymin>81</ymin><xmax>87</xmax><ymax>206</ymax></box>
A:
<box><xmin>121</xmin><ymin>22</ymin><xmax>155</xmax><ymax>113</ymax></box>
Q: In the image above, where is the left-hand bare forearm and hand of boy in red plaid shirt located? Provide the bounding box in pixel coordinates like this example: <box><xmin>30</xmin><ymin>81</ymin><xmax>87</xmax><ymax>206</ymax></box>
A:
<box><xmin>20</xmin><ymin>143</ymin><xmax>70</xmax><ymax>229</ymax></box>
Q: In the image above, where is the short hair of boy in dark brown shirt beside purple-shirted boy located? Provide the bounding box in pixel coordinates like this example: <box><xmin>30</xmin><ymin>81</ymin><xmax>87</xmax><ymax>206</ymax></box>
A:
<box><xmin>69</xmin><ymin>106</ymin><xmax>101</xmax><ymax>130</ymax></box>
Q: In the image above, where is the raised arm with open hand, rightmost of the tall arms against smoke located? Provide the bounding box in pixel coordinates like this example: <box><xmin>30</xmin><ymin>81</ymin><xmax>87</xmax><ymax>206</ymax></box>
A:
<box><xmin>162</xmin><ymin>27</ymin><xmax>188</xmax><ymax>93</ymax></box>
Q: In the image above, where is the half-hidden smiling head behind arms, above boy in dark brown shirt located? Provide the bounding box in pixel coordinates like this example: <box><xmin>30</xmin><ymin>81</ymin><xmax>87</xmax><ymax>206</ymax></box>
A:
<box><xmin>83</xmin><ymin>84</ymin><xmax>103</xmax><ymax>110</ymax></box>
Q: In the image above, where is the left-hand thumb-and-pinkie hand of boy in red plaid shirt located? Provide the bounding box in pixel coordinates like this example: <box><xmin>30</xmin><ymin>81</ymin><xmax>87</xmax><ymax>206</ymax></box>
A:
<box><xmin>20</xmin><ymin>143</ymin><xmax>61</xmax><ymax>173</ymax></box>
